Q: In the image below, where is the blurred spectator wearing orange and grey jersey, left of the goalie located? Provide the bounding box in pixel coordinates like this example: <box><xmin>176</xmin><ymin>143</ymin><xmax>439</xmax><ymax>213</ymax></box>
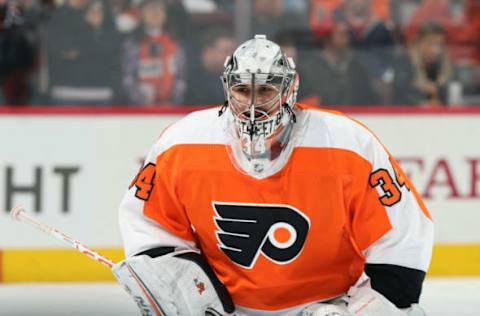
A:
<box><xmin>123</xmin><ymin>0</ymin><xmax>186</xmax><ymax>105</ymax></box>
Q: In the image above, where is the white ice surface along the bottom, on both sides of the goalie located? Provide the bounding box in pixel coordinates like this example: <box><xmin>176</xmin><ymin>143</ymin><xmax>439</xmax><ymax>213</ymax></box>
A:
<box><xmin>0</xmin><ymin>278</ymin><xmax>480</xmax><ymax>316</ymax></box>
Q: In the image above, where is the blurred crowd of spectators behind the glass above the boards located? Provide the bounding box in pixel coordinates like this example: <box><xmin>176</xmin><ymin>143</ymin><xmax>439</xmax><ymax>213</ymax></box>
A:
<box><xmin>0</xmin><ymin>0</ymin><xmax>480</xmax><ymax>107</ymax></box>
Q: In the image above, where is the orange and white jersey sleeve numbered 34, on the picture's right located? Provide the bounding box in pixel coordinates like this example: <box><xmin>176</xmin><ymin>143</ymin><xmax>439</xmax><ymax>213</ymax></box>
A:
<box><xmin>352</xmin><ymin>132</ymin><xmax>433</xmax><ymax>271</ymax></box>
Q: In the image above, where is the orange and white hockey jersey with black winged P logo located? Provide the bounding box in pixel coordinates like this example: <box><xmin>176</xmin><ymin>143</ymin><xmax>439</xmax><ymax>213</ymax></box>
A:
<box><xmin>120</xmin><ymin>104</ymin><xmax>433</xmax><ymax>315</ymax></box>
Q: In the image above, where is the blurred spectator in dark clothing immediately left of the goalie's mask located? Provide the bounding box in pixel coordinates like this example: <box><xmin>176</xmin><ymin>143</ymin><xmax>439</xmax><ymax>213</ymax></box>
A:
<box><xmin>186</xmin><ymin>28</ymin><xmax>235</xmax><ymax>105</ymax></box>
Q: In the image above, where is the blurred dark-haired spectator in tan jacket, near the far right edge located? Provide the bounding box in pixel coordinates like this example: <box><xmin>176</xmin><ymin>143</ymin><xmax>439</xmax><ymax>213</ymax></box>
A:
<box><xmin>393</xmin><ymin>22</ymin><xmax>454</xmax><ymax>105</ymax></box>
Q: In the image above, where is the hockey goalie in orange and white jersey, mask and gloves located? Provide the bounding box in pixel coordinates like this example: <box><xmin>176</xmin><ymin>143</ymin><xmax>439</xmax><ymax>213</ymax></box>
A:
<box><xmin>114</xmin><ymin>35</ymin><xmax>433</xmax><ymax>316</ymax></box>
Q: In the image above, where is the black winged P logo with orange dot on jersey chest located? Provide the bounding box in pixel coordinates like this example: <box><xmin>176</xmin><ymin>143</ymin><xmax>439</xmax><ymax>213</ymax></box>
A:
<box><xmin>213</xmin><ymin>202</ymin><xmax>310</xmax><ymax>269</ymax></box>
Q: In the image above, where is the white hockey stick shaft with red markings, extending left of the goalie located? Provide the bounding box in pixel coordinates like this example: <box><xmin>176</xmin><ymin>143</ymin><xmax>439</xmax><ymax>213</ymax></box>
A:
<box><xmin>10</xmin><ymin>207</ymin><xmax>115</xmax><ymax>268</ymax></box>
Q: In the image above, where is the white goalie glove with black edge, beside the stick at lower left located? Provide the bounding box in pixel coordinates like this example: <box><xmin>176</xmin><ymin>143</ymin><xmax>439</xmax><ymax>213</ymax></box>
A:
<box><xmin>112</xmin><ymin>250</ymin><xmax>235</xmax><ymax>316</ymax></box>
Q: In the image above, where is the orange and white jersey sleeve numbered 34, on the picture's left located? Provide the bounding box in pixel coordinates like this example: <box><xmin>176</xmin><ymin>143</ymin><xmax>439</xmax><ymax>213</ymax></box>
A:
<box><xmin>119</xmin><ymin>140</ymin><xmax>196</xmax><ymax>257</ymax></box>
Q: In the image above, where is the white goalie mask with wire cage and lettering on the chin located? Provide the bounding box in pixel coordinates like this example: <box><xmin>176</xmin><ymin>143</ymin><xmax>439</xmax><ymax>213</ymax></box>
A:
<box><xmin>222</xmin><ymin>35</ymin><xmax>298</xmax><ymax>177</ymax></box>
